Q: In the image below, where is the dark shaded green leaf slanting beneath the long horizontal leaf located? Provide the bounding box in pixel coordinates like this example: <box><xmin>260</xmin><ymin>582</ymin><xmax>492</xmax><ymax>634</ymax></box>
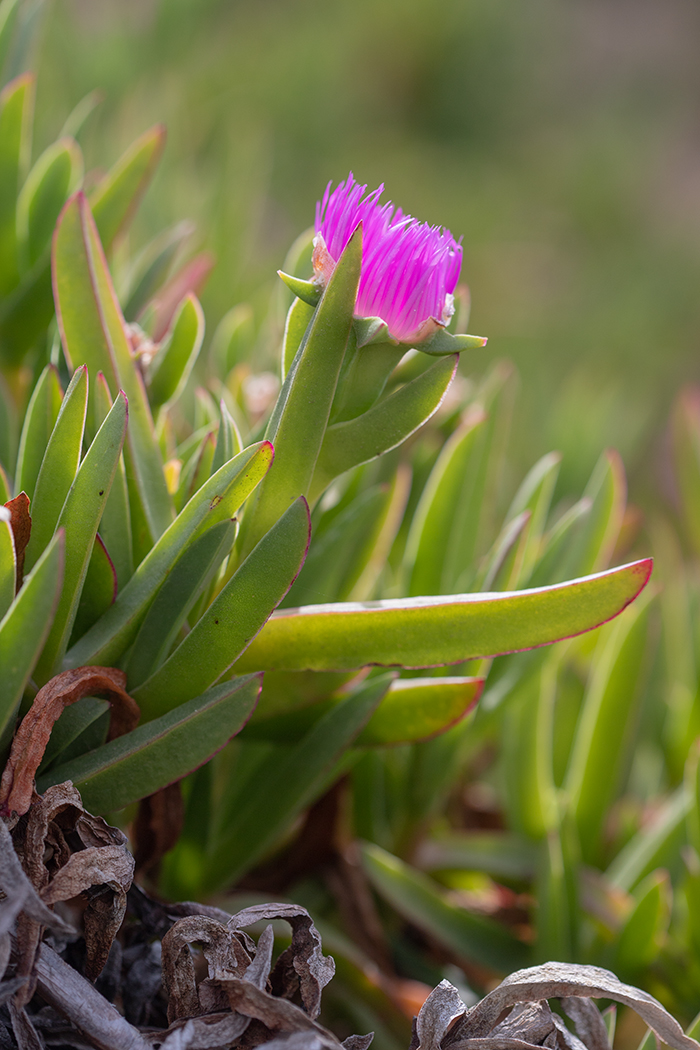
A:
<box><xmin>203</xmin><ymin>675</ymin><xmax>390</xmax><ymax>890</ymax></box>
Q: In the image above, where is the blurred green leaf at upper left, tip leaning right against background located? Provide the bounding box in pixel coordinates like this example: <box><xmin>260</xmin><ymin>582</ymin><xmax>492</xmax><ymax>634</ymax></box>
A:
<box><xmin>90</xmin><ymin>124</ymin><xmax>165</xmax><ymax>251</ymax></box>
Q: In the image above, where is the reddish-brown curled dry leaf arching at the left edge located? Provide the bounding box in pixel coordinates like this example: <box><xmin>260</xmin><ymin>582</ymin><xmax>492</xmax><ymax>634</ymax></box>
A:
<box><xmin>0</xmin><ymin>667</ymin><xmax>141</xmax><ymax>816</ymax></box>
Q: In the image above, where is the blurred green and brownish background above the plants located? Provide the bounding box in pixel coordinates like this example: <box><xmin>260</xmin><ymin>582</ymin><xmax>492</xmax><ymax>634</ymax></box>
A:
<box><xmin>35</xmin><ymin>0</ymin><xmax>700</xmax><ymax>501</ymax></box>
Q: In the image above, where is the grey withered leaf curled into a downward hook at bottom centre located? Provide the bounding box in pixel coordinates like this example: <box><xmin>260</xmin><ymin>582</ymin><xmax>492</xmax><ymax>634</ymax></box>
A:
<box><xmin>229</xmin><ymin>904</ymin><xmax>336</xmax><ymax>1017</ymax></box>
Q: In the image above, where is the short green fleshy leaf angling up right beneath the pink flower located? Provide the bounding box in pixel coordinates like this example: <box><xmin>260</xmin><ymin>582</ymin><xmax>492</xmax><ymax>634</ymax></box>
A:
<box><xmin>311</xmin><ymin>357</ymin><xmax>459</xmax><ymax>500</ymax></box>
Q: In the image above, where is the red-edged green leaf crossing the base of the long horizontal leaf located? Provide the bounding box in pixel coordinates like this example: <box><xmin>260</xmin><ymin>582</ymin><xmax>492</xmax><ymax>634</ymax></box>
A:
<box><xmin>133</xmin><ymin>497</ymin><xmax>311</xmax><ymax>719</ymax></box>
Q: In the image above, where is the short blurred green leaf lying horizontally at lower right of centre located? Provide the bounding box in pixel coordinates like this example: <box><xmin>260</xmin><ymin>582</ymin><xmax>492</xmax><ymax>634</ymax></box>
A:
<box><xmin>415</xmin><ymin>832</ymin><xmax>538</xmax><ymax>879</ymax></box>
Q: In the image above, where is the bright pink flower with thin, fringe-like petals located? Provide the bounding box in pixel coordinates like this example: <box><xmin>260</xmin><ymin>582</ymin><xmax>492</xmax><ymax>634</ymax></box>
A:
<box><xmin>314</xmin><ymin>172</ymin><xmax>462</xmax><ymax>343</ymax></box>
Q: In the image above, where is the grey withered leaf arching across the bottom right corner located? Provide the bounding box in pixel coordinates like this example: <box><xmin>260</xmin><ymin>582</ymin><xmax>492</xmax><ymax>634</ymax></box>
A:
<box><xmin>454</xmin><ymin>963</ymin><xmax>700</xmax><ymax>1050</ymax></box>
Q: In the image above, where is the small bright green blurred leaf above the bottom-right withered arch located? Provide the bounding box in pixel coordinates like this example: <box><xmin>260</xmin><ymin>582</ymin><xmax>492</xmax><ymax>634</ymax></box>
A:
<box><xmin>614</xmin><ymin>872</ymin><xmax>671</xmax><ymax>977</ymax></box>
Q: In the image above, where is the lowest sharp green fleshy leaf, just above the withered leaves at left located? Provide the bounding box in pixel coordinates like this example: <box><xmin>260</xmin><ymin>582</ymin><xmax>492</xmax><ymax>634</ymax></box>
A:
<box><xmin>38</xmin><ymin>675</ymin><xmax>260</xmax><ymax>813</ymax></box>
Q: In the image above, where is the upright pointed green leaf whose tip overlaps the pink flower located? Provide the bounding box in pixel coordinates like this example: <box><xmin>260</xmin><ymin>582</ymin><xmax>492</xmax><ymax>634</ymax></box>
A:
<box><xmin>240</xmin><ymin>228</ymin><xmax>362</xmax><ymax>558</ymax></box>
